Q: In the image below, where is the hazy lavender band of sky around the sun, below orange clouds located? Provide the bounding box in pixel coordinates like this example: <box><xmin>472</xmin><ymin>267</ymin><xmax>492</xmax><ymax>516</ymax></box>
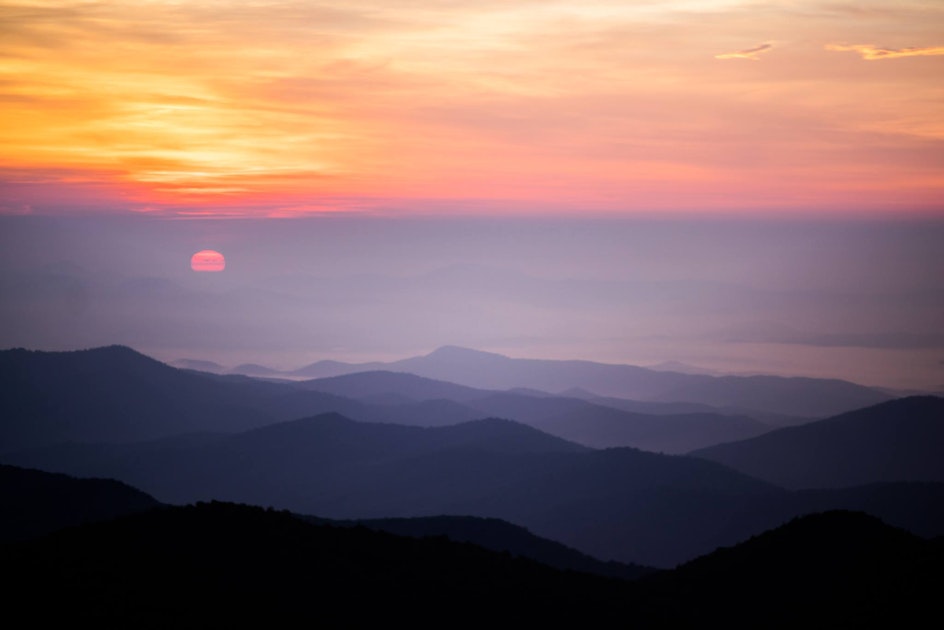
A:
<box><xmin>0</xmin><ymin>213</ymin><xmax>944</xmax><ymax>391</ymax></box>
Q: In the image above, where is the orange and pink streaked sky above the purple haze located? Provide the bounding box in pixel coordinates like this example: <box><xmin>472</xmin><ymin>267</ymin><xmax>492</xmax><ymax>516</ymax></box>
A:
<box><xmin>0</xmin><ymin>0</ymin><xmax>944</xmax><ymax>216</ymax></box>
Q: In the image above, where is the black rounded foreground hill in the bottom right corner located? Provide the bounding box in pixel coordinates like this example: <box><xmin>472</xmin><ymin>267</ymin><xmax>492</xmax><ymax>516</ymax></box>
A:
<box><xmin>647</xmin><ymin>511</ymin><xmax>944</xmax><ymax>628</ymax></box>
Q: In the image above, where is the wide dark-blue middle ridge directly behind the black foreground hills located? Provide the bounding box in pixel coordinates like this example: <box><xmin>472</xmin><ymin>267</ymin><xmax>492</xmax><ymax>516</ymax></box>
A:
<box><xmin>6</xmin><ymin>414</ymin><xmax>944</xmax><ymax>567</ymax></box>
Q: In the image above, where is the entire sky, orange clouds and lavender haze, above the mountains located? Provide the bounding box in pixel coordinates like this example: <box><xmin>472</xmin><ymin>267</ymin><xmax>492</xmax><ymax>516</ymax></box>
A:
<box><xmin>0</xmin><ymin>0</ymin><xmax>944</xmax><ymax>390</ymax></box>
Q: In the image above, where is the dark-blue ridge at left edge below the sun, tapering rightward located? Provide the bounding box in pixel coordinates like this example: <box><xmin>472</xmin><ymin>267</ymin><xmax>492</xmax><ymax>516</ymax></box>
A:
<box><xmin>0</xmin><ymin>346</ymin><xmax>384</xmax><ymax>451</ymax></box>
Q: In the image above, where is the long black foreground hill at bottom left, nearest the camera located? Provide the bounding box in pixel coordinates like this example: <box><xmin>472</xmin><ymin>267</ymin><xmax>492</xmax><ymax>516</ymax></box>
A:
<box><xmin>3</xmin><ymin>502</ymin><xmax>627</xmax><ymax>627</ymax></box>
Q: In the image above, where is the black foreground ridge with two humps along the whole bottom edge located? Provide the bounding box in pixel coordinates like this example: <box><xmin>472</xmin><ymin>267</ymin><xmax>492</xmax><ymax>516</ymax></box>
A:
<box><xmin>0</xmin><ymin>502</ymin><xmax>944</xmax><ymax>628</ymax></box>
